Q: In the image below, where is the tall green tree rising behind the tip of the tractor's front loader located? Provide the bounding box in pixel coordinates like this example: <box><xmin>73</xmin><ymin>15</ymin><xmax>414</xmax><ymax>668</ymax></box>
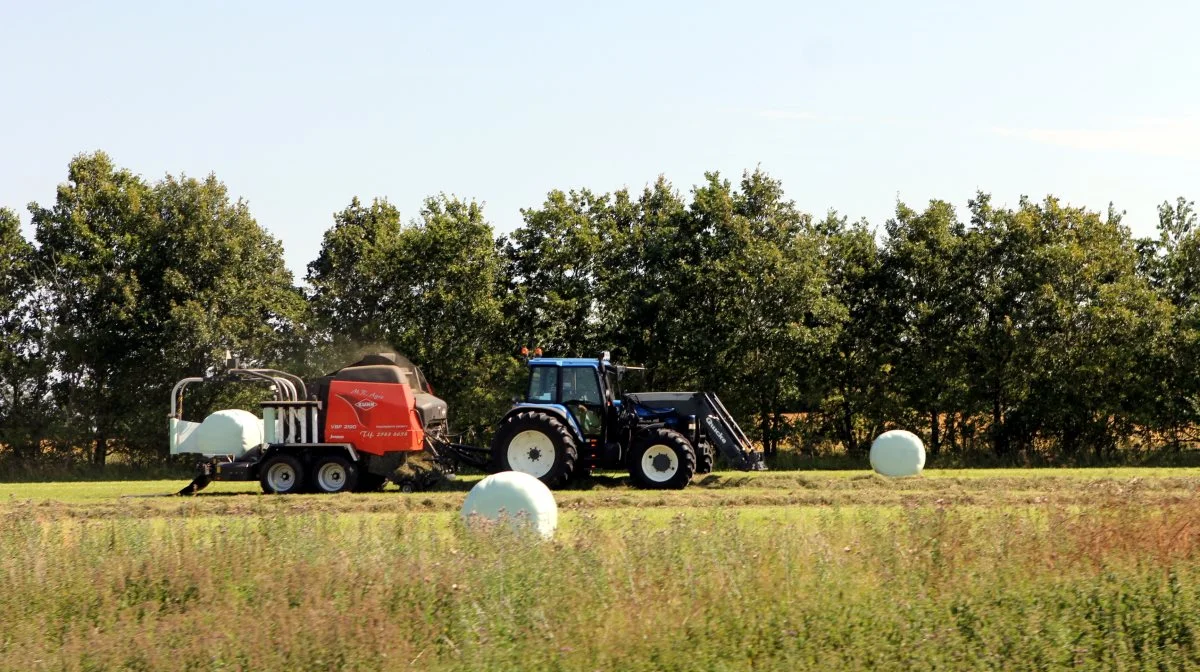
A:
<box><xmin>688</xmin><ymin>170</ymin><xmax>840</xmax><ymax>455</ymax></box>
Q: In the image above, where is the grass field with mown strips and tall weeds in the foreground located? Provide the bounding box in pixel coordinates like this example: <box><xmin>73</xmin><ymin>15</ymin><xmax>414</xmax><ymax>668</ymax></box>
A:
<box><xmin>0</xmin><ymin>469</ymin><xmax>1200</xmax><ymax>670</ymax></box>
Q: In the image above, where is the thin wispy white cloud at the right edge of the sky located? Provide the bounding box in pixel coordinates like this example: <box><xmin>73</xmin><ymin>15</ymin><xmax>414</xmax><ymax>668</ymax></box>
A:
<box><xmin>990</xmin><ymin>116</ymin><xmax>1200</xmax><ymax>158</ymax></box>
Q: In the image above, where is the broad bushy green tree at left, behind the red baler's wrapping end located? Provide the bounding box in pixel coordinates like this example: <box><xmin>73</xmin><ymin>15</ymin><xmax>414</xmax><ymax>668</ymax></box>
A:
<box><xmin>30</xmin><ymin>152</ymin><xmax>302</xmax><ymax>464</ymax></box>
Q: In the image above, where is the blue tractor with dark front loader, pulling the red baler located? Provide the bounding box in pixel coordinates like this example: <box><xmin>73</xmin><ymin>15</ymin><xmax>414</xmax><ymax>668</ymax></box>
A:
<box><xmin>490</xmin><ymin>353</ymin><xmax>764</xmax><ymax>490</ymax></box>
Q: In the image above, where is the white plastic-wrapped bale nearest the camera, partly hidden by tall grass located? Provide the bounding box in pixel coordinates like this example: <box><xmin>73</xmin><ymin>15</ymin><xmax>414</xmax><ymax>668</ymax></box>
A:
<box><xmin>462</xmin><ymin>472</ymin><xmax>558</xmax><ymax>539</ymax></box>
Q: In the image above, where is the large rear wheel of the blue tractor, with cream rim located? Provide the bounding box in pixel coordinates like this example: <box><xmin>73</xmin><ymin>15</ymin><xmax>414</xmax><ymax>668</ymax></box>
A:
<box><xmin>492</xmin><ymin>410</ymin><xmax>580</xmax><ymax>487</ymax></box>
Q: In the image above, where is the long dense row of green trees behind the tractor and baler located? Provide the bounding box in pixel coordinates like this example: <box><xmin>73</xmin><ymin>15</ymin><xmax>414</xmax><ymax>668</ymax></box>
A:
<box><xmin>0</xmin><ymin>152</ymin><xmax>1200</xmax><ymax>463</ymax></box>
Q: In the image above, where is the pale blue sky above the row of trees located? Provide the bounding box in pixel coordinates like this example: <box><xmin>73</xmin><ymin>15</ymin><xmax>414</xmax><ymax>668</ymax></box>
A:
<box><xmin>0</xmin><ymin>0</ymin><xmax>1200</xmax><ymax>277</ymax></box>
